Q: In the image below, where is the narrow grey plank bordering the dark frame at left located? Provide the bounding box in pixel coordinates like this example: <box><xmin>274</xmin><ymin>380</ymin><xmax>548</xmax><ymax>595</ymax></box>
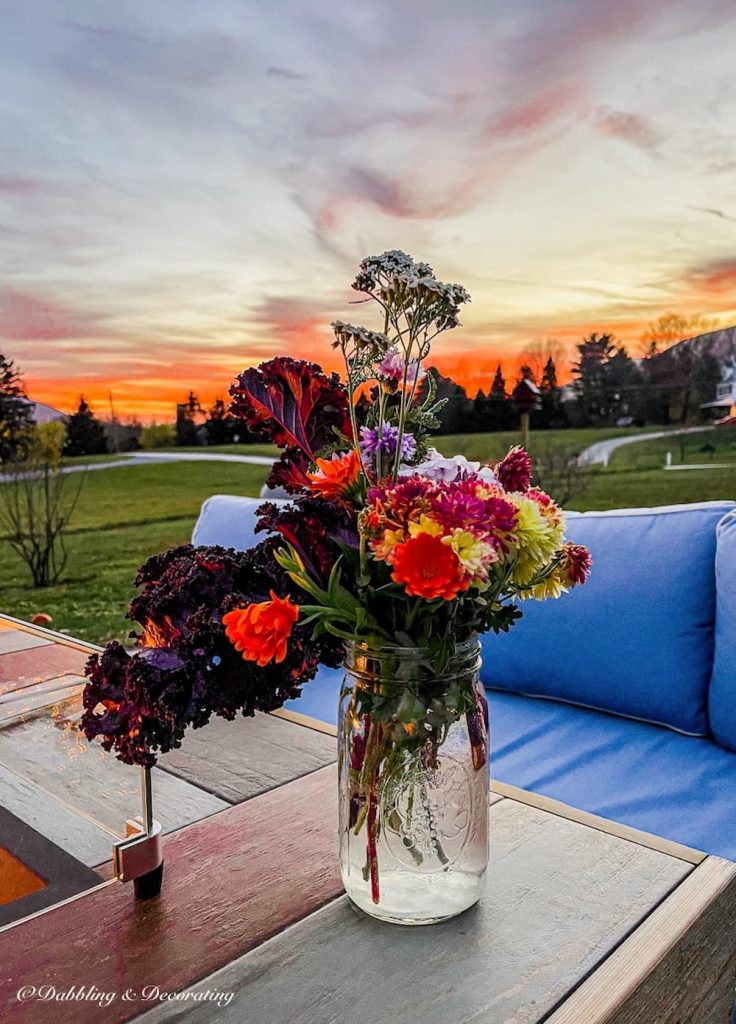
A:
<box><xmin>0</xmin><ymin>765</ymin><xmax>113</xmax><ymax>867</ymax></box>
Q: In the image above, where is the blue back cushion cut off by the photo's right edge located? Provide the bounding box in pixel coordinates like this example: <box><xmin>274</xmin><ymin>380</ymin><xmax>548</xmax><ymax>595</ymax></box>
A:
<box><xmin>708</xmin><ymin>512</ymin><xmax>736</xmax><ymax>751</ymax></box>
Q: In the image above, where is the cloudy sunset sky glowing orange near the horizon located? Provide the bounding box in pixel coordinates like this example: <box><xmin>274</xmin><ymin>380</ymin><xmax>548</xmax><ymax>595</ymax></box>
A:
<box><xmin>0</xmin><ymin>0</ymin><xmax>736</xmax><ymax>419</ymax></box>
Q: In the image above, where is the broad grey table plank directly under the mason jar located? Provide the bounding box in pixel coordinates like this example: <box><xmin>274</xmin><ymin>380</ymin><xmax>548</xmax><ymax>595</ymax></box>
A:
<box><xmin>139</xmin><ymin>800</ymin><xmax>692</xmax><ymax>1024</ymax></box>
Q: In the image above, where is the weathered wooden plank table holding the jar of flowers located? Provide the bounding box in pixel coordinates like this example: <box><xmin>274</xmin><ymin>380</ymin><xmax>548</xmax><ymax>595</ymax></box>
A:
<box><xmin>0</xmin><ymin>623</ymin><xmax>736</xmax><ymax>1024</ymax></box>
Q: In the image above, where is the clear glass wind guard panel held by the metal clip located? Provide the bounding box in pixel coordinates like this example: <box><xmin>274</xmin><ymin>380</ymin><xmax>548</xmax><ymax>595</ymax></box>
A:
<box><xmin>0</xmin><ymin>617</ymin><xmax>142</xmax><ymax>925</ymax></box>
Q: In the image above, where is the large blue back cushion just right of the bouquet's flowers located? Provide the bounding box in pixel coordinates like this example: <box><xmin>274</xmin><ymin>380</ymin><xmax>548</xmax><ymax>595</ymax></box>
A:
<box><xmin>483</xmin><ymin>502</ymin><xmax>734</xmax><ymax>735</ymax></box>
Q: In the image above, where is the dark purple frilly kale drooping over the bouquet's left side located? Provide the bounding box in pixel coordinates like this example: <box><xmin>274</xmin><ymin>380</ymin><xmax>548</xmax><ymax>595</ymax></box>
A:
<box><xmin>82</xmin><ymin>539</ymin><xmax>342</xmax><ymax>766</ymax></box>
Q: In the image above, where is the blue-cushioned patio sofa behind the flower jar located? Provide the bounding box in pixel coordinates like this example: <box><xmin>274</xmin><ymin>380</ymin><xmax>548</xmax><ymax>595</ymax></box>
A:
<box><xmin>192</xmin><ymin>496</ymin><xmax>736</xmax><ymax>860</ymax></box>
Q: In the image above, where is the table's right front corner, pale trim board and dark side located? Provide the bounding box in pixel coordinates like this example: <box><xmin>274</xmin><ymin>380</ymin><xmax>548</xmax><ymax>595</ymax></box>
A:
<box><xmin>548</xmin><ymin>857</ymin><xmax>736</xmax><ymax>1024</ymax></box>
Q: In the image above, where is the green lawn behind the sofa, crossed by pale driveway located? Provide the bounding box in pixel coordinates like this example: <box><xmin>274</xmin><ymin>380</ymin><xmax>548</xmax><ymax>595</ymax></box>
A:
<box><xmin>0</xmin><ymin>430</ymin><xmax>736</xmax><ymax>642</ymax></box>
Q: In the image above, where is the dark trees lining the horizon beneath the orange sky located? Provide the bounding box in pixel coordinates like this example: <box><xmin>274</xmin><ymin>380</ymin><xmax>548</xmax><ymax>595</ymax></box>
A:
<box><xmin>0</xmin><ymin>314</ymin><xmax>722</xmax><ymax>464</ymax></box>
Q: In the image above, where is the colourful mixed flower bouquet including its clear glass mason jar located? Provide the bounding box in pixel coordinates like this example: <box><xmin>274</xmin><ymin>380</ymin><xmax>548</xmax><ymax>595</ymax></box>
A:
<box><xmin>83</xmin><ymin>252</ymin><xmax>590</xmax><ymax>923</ymax></box>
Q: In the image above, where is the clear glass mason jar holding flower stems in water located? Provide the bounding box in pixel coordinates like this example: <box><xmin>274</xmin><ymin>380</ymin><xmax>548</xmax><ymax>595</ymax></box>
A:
<box><xmin>338</xmin><ymin>638</ymin><xmax>489</xmax><ymax>925</ymax></box>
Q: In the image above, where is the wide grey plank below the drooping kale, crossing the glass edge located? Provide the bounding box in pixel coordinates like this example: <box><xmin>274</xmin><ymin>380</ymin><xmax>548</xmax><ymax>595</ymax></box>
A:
<box><xmin>0</xmin><ymin>711</ymin><xmax>228</xmax><ymax>836</ymax></box>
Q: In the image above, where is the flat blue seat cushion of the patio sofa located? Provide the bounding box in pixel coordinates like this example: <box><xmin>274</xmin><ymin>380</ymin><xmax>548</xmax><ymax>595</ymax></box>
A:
<box><xmin>287</xmin><ymin>669</ymin><xmax>736</xmax><ymax>860</ymax></box>
